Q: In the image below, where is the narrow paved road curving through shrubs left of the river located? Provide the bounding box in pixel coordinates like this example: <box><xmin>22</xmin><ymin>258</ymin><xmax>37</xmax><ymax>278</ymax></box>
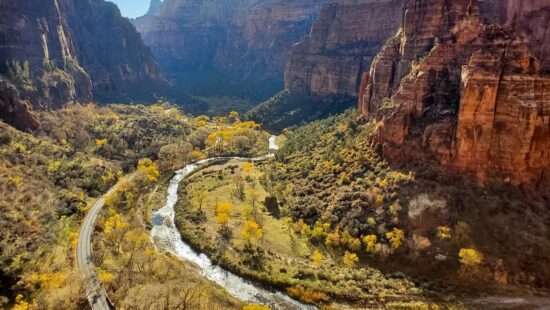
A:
<box><xmin>76</xmin><ymin>196</ymin><xmax>113</xmax><ymax>310</ymax></box>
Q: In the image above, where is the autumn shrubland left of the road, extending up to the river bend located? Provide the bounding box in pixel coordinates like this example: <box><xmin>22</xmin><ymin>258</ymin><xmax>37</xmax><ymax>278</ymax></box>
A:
<box><xmin>0</xmin><ymin>102</ymin><xmax>267</xmax><ymax>309</ymax></box>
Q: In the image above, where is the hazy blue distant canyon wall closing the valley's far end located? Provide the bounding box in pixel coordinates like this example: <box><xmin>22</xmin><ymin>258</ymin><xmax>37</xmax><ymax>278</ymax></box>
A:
<box><xmin>134</xmin><ymin>0</ymin><xmax>326</xmax><ymax>99</ymax></box>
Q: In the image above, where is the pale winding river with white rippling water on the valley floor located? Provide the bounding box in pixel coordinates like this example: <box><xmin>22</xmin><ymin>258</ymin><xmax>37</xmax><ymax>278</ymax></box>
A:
<box><xmin>151</xmin><ymin>136</ymin><xmax>316</xmax><ymax>310</ymax></box>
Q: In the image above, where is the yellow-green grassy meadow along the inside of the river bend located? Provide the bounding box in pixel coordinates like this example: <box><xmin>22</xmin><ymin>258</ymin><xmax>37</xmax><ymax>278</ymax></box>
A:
<box><xmin>170</xmin><ymin>161</ymin><xmax>446</xmax><ymax>305</ymax></box>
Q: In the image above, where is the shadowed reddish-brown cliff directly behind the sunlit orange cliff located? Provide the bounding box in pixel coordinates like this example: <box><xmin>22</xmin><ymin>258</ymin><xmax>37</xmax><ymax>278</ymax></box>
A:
<box><xmin>285</xmin><ymin>0</ymin><xmax>403</xmax><ymax>97</ymax></box>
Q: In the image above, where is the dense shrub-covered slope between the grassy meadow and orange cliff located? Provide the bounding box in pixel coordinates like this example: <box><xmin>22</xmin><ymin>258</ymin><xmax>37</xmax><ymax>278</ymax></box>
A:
<box><xmin>270</xmin><ymin>111</ymin><xmax>550</xmax><ymax>294</ymax></box>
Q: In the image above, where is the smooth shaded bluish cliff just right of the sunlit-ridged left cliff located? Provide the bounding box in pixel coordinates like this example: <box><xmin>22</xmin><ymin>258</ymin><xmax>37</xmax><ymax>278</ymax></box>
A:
<box><xmin>64</xmin><ymin>0</ymin><xmax>166</xmax><ymax>102</ymax></box>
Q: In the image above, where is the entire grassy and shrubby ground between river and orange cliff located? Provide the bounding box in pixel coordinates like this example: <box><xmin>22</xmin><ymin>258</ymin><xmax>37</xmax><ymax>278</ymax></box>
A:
<box><xmin>183</xmin><ymin>110</ymin><xmax>550</xmax><ymax>309</ymax></box>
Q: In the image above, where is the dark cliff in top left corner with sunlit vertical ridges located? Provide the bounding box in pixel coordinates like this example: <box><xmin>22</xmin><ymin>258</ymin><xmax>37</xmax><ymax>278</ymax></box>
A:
<box><xmin>0</xmin><ymin>0</ymin><xmax>92</xmax><ymax>108</ymax></box>
